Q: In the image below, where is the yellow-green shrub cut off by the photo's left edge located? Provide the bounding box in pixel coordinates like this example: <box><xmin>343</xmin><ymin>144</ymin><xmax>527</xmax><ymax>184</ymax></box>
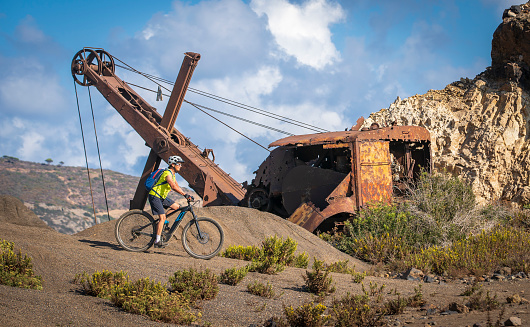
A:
<box><xmin>0</xmin><ymin>240</ymin><xmax>42</xmax><ymax>290</ymax></box>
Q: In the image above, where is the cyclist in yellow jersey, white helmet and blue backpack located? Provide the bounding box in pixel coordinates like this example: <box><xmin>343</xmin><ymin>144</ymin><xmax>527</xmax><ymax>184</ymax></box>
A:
<box><xmin>148</xmin><ymin>156</ymin><xmax>192</xmax><ymax>248</ymax></box>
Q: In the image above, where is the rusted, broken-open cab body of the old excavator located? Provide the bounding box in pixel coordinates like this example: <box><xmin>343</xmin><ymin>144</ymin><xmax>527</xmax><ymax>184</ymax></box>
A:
<box><xmin>244</xmin><ymin>120</ymin><xmax>432</xmax><ymax>232</ymax></box>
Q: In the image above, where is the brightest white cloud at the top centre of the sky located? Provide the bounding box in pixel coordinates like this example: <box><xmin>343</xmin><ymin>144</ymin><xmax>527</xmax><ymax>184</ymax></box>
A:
<box><xmin>250</xmin><ymin>0</ymin><xmax>345</xmax><ymax>69</ymax></box>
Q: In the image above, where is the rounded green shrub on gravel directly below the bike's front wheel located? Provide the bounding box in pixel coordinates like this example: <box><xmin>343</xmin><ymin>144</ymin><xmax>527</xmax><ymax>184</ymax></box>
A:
<box><xmin>169</xmin><ymin>268</ymin><xmax>219</xmax><ymax>303</ymax></box>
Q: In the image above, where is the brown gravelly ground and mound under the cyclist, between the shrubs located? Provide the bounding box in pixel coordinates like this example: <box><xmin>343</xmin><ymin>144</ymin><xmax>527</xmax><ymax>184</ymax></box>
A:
<box><xmin>0</xmin><ymin>196</ymin><xmax>530</xmax><ymax>326</ymax></box>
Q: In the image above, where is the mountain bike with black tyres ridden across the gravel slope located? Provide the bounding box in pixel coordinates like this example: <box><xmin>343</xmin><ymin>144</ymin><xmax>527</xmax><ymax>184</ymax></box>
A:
<box><xmin>114</xmin><ymin>199</ymin><xmax>224</xmax><ymax>259</ymax></box>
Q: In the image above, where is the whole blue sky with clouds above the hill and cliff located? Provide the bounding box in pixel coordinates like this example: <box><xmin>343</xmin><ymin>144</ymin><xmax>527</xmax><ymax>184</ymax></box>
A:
<box><xmin>0</xmin><ymin>0</ymin><xmax>519</xmax><ymax>187</ymax></box>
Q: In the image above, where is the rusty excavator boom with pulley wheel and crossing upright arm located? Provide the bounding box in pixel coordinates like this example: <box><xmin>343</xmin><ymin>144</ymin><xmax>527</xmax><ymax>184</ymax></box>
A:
<box><xmin>71</xmin><ymin>48</ymin><xmax>245</xmax><ymax>209</ymax></box>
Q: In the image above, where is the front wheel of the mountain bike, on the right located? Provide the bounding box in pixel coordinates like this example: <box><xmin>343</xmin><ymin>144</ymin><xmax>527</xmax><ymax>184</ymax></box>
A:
<box><xmin>182</xmin><ymin>217</ymin><xmax>225</xmax><ymax>260</ymax></box>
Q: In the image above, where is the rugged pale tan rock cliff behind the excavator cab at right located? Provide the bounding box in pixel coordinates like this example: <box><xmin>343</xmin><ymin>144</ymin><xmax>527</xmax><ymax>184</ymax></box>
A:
<box><xmin>363</xmin><ymin>1</ymin><xmax>530</xmax><ymax>204</ymax></box>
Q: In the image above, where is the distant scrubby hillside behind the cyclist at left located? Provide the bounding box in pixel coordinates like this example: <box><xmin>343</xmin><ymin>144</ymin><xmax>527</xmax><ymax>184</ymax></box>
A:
<box><xmin>0</xmin><ymin>156</ymin><xmax>193</xmax><ymax>234</ymax></box>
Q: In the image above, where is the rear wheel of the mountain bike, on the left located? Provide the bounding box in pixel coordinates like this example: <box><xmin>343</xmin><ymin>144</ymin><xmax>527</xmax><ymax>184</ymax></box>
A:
<box><xmin>114</xmin><ymin>209</ymin><xmax>156</xmax><ymax>252</ymax></box>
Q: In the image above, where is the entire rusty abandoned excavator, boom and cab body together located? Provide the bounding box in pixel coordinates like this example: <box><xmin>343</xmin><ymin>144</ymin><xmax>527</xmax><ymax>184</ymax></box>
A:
<box><xmin>71</xmin><ymin>48</ymin><xmax>432</xmax><ymax>232</ymax></box>
